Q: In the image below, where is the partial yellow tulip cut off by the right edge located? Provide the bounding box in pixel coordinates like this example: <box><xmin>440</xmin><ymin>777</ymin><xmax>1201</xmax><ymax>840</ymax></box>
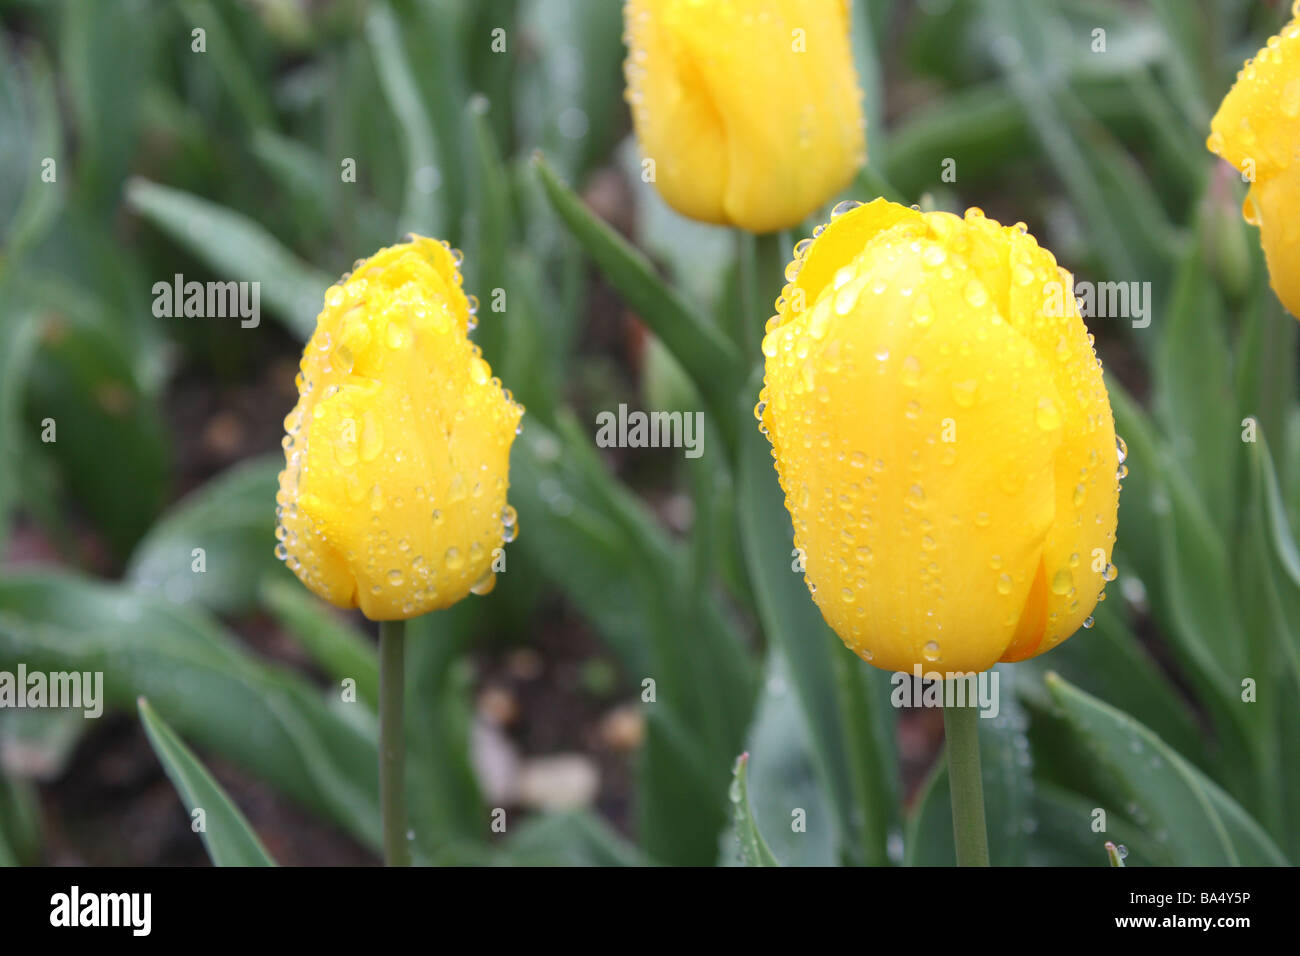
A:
<box><xmin>1205</xmin><ymin>3</ymin><xmax>1300</xmax><ymax>316</ymax></box>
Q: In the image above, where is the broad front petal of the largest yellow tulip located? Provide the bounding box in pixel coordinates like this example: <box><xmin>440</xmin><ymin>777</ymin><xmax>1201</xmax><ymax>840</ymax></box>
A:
<box><xmin>764</xmin><ymin>221</ymin><xmax>1060</xmax><ymax>671</ymax></box>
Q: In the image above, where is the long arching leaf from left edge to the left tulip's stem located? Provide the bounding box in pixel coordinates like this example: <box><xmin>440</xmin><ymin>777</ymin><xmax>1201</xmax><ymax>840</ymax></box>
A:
<box><xmin>0</xmin><ymin>571</ymin><xmax>380</xmax><ymax>845</ymax></box>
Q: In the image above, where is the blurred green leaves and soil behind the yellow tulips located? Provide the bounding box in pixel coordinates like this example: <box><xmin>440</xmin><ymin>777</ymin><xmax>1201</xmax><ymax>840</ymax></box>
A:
<box><xmin>0</xmin><ymin>0</ymin><xmax>1300</xmax><ymax>865</ymax></box>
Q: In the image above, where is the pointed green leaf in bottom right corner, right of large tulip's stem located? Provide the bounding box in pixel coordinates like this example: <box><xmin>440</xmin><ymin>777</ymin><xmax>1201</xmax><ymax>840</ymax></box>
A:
<box><xmin>1047</xmin><ymin>674</ymin><xmax>1287</xmax><ymax>866</ymax></box>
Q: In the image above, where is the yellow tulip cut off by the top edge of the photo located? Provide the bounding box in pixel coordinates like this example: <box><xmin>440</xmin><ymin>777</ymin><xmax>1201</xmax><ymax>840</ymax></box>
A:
<box><xmin>624</xmin><ymin>0</ymin><xmax>866</xmax><ymax>233</ymax></box>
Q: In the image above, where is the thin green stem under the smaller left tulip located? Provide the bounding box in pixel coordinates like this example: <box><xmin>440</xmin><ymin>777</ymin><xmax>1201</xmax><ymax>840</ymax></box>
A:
<box><xmin>380</xmin><ymin>620</ymin><xmax>411</xmax><ymax>866</ymax></box>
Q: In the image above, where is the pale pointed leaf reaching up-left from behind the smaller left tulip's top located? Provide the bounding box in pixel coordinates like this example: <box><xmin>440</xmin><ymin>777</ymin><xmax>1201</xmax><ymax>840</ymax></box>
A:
<box><xmin>126</xmin><ymin>178</ymin><xmax>334</xmax><ymax>339</ymax></box>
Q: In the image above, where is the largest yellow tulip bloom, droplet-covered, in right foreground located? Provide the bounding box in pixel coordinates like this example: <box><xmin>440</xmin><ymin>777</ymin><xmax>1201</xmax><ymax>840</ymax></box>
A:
<box><xmin>755</xmin><ymin>199</ymin><xmax>1123</xmax><ymax>672</ymax></box>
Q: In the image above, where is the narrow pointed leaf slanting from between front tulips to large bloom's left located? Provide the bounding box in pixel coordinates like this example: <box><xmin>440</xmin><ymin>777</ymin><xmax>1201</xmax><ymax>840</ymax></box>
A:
<box><xmin>533</xmin><ymin>156</ymin><xmax>742</xmax><ymax>444</ymax></box>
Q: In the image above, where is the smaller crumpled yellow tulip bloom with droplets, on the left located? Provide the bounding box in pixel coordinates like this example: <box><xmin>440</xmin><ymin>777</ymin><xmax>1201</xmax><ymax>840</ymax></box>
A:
<box><xmin>276</xmin><ymin>237</ymin><xmax>524</xmax><ymax>620</ymax></box>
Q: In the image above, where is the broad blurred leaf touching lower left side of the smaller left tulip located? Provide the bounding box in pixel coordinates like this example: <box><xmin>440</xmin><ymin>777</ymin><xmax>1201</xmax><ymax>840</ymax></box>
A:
<box><xmin>126</xmin><ymin>454</ymin><xmax>291</xmax><ymax>613</ymax></box>
